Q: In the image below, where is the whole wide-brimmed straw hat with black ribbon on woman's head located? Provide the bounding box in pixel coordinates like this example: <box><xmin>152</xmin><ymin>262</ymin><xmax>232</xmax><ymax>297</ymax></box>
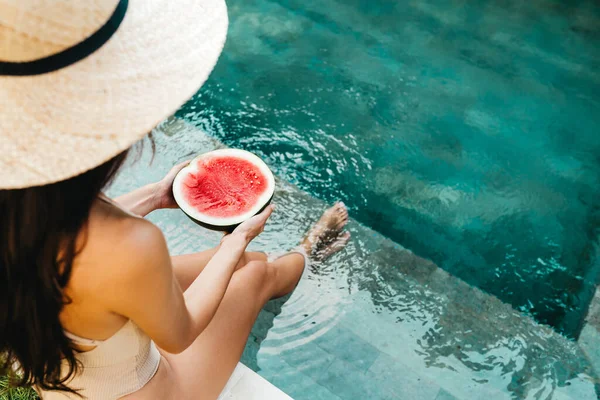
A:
<box><xmin>0</xmin><ymin>0</ymin><xmax>227</xmax><ymax>189</ymax></box>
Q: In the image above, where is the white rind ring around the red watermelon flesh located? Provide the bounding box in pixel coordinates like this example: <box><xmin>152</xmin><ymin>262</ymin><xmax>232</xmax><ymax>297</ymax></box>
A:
<box><xmin>173</xmin><ymin>149</ymin><xmax>275</xmax><ymax>227</ymax></box>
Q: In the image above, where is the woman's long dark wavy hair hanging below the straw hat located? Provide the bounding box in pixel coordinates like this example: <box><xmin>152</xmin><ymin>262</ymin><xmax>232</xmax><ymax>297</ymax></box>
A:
<box><xmin>0</xmin><ymin>151</ymin><xmax>127</xmax><ymax>393</ymax></box>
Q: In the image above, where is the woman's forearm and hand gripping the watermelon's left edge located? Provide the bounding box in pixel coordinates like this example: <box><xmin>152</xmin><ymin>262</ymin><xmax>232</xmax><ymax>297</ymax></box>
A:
<box><xmin>114</xmin><ymin>161</ymin><xmax>190</xmax><ymax>217</ymax></box>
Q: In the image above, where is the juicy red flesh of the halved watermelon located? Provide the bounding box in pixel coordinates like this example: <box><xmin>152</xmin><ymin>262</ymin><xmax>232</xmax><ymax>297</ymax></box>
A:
<box><xmin>182</xmin><ymin>156</ymin><xmax>269</xmax><ymax>218</ymax></box>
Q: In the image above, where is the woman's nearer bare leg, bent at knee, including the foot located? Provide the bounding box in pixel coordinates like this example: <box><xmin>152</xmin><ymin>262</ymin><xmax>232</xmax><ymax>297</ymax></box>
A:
<box><xmin>163</xmin><ymin>203</ymin><xmax>349</xmax><ymax>400</ymax></box>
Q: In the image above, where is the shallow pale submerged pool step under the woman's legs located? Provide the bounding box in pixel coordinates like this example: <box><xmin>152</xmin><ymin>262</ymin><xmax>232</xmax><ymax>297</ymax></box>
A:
<box><xmin>113</xmin><ymin>119</ymin><xmax>600</xmax><ymax>400</ymax></box>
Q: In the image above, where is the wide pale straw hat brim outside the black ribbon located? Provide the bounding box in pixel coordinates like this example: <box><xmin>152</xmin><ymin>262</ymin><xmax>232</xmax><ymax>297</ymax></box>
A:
<box><xmin>0</xmin><ymin>0</ymin><xmax>228</xmax><ymax>189</ymax></box>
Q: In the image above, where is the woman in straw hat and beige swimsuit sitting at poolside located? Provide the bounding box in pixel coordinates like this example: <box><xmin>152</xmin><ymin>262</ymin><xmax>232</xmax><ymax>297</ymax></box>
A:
<box><xmin>0</xmin><ymin>0</ymin><xmax>349</xmax><ymax>400</ymax></box>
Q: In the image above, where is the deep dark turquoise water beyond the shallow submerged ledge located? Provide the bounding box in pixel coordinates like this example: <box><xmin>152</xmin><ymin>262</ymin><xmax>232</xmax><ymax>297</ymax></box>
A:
<box><xmin>178</xmin><ymin>0</ymin><xmax>600</xmax><ymax>337</ymax></box>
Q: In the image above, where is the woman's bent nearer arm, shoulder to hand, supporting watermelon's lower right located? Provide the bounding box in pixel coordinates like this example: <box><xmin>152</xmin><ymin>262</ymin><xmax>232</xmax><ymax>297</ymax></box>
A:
<box><xmin>105</xmin><ymin>207</ymin><xmax>272</xmax><ymax>353</ymax></box>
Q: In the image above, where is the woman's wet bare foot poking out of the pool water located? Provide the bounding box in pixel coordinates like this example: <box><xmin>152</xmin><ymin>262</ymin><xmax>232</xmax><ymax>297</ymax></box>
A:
<box><xmin>302</xmin><ymin>201</ymin><xmax>350</xmax><ymax>260</ymax></box>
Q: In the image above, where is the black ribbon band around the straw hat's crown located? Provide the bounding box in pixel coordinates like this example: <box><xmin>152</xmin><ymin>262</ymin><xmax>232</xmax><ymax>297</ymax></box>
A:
<box><xmin>0</xmin><ymin>0</ymin><xmax>129</xmax><ymax>76</ymax></box>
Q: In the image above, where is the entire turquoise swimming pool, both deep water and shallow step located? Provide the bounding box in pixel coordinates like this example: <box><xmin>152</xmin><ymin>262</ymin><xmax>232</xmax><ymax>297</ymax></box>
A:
<box><xmin>112</xmin><ymin>0</ymin><xmax>600</xmax><ymax>400</ymax></box>
